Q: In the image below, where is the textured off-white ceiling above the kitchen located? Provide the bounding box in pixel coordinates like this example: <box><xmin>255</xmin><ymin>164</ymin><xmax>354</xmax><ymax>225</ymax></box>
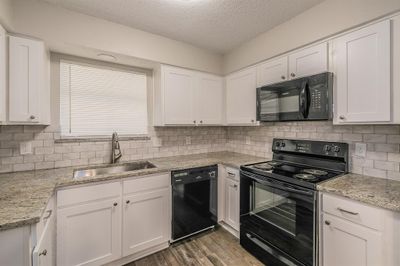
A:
<box><xmin>42</xmin><ymin>0</ymin><xmax>322</xmax><ymax>53</ymax></box>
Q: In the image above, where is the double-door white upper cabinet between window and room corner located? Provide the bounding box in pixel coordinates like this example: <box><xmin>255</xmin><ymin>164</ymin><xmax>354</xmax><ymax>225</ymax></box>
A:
<box><xmin>154</xmin><ymin>65</ymin><xmax>224</xmax><ymax>126</ymax></box>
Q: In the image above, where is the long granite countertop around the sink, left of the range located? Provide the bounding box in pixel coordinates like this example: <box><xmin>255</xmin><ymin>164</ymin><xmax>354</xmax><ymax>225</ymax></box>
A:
<box><xmin>0</xmin><ymin>152</ymin><xmax>266</xmax><ymax>230</ymax></box>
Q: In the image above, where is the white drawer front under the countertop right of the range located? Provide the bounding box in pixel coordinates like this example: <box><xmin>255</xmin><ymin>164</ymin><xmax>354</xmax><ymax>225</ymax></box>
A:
<box><xmin>322</xmin><ymin>194</ymin><xmax>384</xmax><ymax>230</ymax></box>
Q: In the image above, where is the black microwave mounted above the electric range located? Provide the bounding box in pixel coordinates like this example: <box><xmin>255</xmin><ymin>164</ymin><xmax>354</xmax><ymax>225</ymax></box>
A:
<box><xmin>257</xmin><ymin>72</ymin><xmax>333</xmax><ymax>122</ymax></box>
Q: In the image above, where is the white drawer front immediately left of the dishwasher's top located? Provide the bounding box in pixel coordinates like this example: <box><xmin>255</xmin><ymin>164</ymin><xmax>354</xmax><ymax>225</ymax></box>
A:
<box><xmin>123</xmin><ymin>173</ymin><xmax>171</xmax><ymax>194</ymax></box>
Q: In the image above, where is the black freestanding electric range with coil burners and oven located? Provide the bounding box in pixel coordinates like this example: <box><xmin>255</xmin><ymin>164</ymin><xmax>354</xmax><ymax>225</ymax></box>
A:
<box><xmin>240</xmin><ymin>139</ymin><xmax>348</xmax><ymax>266</ymax></box>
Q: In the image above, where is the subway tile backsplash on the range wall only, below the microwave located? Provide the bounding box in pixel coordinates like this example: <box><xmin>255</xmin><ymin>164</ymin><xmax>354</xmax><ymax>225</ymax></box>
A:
<box><xmin>226</xmin><ymin>121</ymin><xmax>400</xmax><ymax>181</ymax></box>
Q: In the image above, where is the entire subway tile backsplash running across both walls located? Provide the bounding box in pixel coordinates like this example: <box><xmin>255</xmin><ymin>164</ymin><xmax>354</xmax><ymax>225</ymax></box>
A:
<box><xmin>0</xmin><ymin>121</ymin><xmax>400</xmax><ymax>180</ymax></box>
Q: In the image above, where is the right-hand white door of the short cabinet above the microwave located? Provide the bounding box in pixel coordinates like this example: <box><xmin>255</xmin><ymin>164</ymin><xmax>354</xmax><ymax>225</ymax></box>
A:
<box><xmin>289</xmin><ymin>43</ymin><xmax>328</xmax><ymax>79</ymax></box>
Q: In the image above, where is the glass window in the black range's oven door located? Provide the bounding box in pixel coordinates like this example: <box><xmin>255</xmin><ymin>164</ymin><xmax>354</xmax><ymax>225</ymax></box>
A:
<box><xmin>251</xmin><ymin>183</ymin><xmax>296</xmax><ymax>236</ymax></box>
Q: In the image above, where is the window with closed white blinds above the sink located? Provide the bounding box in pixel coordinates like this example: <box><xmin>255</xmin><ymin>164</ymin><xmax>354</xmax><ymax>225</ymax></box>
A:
<box><xmin>60</xmin><ymin>61</ymin><xmax>147</xmax><ymax>137</ymax></box>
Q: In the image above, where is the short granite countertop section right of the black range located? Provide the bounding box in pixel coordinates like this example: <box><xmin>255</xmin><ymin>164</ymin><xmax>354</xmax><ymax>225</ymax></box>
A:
<box><xmin>317</xmin><ymin>174</ymin><xmax>400</xmax><ymax>212</ymax></box>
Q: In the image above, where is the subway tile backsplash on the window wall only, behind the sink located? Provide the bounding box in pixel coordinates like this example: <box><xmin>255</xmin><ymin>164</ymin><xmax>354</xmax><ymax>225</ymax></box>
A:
<box><xmin>0</xmin><ymin>126</ymin><xmax>226</xmax><ymax>173</ymax></box>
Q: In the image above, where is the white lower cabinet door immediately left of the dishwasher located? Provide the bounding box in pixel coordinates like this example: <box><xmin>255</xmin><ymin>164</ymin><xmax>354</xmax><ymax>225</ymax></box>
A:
<box><xmin>123</xmin><ymin>189</ymin><xmax>171</xmax><ymax>256</ymax></box>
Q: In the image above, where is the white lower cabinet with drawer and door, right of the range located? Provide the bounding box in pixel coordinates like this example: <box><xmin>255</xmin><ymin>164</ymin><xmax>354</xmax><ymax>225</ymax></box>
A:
<box><xmin>319</xmin><ymin>193</ymin><xmax>400</xmax><ymax>266</ymax></box>
